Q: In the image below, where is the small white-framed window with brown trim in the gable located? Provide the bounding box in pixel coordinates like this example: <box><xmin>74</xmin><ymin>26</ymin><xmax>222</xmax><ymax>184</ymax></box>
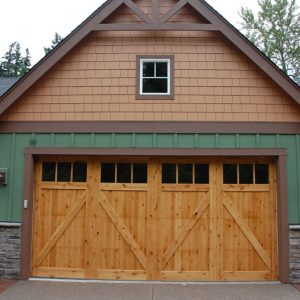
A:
<box><xmin>137</xmin><ymin>56</ymin><xmax>173</xmax><ymax>99</ymax></box>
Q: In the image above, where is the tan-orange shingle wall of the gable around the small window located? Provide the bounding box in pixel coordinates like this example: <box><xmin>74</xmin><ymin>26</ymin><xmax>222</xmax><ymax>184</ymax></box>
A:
<box><xmin>3</xmin><ymin>0</ymin><xmax>300</xmax><ymax>122</ymax></box>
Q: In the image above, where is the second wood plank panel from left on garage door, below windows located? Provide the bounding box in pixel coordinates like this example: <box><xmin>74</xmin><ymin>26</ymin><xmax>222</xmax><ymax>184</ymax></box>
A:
<box><xmin>95</xmin><ymin>186</ymin><xmax>147</xmax><ymax>279</ymax></box>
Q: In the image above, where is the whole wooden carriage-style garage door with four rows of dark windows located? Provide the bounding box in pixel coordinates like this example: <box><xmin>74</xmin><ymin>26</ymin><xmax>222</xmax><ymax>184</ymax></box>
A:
<box><xmin>31</xmin><ymin>157</ymin><xmax>278</xmax><ymax>280</ymax></box>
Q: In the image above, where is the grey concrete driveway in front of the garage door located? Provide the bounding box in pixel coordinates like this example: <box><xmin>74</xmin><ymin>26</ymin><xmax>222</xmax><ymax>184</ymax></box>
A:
<box><xmin>0</xmin><ymin>280</ymin><xmax>300</xmax><ymax>300</ymax></box>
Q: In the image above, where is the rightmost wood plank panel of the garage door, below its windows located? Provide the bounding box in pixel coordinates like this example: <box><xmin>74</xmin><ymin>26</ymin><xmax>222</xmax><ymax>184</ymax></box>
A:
<box><xmin>222</xmin><ymin>159</ymin><xmax>278</xmax><ymax>280</ymax></box>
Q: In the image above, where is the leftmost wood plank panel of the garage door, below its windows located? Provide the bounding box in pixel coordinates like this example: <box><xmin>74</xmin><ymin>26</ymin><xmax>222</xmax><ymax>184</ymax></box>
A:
<box><xmin>32</xmin><ymin>164</ymin><xmax>87</xmax><ymax>277</ymax></box>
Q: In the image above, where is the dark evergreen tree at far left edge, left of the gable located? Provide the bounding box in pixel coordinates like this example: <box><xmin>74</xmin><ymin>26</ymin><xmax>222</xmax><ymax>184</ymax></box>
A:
<box><xmin>0</xmin><ymin>42</ymin><xmax>31</xmax><ymax>77</ymax></box>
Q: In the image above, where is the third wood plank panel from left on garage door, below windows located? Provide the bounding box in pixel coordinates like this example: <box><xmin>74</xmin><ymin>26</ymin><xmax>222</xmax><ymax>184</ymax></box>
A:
<box><xmin>158</xmin><ymin>186</ymin><xmax>209</xmax><ymax>280</ymax></box>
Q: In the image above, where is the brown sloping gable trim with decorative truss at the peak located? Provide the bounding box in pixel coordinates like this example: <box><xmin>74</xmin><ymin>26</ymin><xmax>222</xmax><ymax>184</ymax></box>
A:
<box><xmin>0</xmin><ymin>0</ymin><xmax>300</xmax><ymax>115</ymax></box>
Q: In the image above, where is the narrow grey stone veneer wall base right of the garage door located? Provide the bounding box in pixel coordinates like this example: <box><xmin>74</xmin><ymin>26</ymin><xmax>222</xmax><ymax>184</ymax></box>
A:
<box><xmin>290</xmin><ymin>226</ymin><xmax>300</xmax><ymax>283</ymax></box>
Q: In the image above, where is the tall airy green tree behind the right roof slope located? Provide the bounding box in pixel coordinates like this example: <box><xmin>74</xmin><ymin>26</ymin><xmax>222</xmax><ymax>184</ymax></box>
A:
<box><xmin>240</xmin><ymin>0</ymin><xmax>300</xmax><ymax>80</ymax></box>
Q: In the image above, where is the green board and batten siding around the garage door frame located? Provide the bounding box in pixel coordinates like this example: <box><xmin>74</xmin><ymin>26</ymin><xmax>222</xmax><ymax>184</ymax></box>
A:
<box><xmin>0</xmin><ymin>133</ymin><xmax>300</xmax><ymax>224</ymax></box>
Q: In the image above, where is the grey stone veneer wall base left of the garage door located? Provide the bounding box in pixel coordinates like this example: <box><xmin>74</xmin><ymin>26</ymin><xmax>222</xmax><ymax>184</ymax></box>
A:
<box><xmin>0</xmin><ymin>223</ymin><xmax>21</xmax><ymax>280</ymax></box>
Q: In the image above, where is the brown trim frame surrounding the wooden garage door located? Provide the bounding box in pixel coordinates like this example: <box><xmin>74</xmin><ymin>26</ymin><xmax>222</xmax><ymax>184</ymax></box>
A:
<box><xmin>20</xmin><ymin>147</ymin><xmax>290</xmax><ymax>283</ymax></box>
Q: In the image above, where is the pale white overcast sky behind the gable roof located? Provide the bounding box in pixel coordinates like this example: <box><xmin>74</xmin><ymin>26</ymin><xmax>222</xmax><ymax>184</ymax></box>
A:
<box><xmin>0</xmin><ymin>0</ymin><xmax>260</xmax><ymax>65</ymax></box>
